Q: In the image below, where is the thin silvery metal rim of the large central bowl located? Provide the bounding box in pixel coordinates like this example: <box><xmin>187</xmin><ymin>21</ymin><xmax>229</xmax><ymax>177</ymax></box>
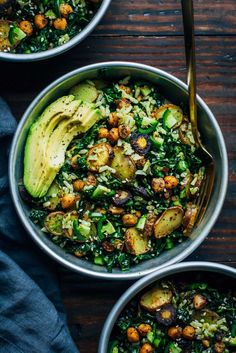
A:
<box><xmin>9</xmin><ymin>61</ymin><xmax>228</xmax><ymax>280</ymax></box>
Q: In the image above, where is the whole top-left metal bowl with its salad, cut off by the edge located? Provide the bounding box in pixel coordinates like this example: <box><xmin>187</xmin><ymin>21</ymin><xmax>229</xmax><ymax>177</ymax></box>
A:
<box><xmin>0</xmin><ymin>0</ymin><xmax>111</xmax><ymax>62</ymax></box>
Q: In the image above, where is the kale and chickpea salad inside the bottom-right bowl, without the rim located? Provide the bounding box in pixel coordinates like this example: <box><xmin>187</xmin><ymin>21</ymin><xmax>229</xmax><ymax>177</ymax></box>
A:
<box><xmin>108</xmin><ymin>281</ymin><xmax>236</xmax><ymax>353</ymax></box>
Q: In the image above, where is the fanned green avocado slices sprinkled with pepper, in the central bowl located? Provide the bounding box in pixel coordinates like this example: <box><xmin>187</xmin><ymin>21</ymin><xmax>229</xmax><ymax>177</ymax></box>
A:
<box><xmin>23</xmin><ymin>95</ymin><xmax>100</xmax><ymax>197</ymax></box>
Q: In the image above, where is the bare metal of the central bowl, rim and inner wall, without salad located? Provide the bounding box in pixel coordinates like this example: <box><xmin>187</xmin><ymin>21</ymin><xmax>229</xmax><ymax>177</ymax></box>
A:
<box><xmin>9</xmin><ymin>62</ymin><xmax>228</xmax><ymax>280</ymax></box>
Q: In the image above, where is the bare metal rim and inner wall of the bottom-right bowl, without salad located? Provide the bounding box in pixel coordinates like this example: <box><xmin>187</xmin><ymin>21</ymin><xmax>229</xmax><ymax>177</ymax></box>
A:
<box><xmin>98</xmin><ymin>262</ymin><xmax>236</xmax><ymax>353</ymax></box>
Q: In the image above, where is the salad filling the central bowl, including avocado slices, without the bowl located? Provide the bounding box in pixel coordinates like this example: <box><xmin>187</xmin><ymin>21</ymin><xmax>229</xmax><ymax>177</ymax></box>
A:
<box><xmin>20</xmin><ymin>78</ymin><xmax>204</xmax><ymax>271</ymax></box>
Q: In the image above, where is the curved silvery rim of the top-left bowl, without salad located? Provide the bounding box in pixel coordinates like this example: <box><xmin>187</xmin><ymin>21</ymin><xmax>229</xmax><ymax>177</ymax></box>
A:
<box><xmin>0</xmin><ymin>0</ymin><xmax>111</xmax><ymax>62</ymax></box>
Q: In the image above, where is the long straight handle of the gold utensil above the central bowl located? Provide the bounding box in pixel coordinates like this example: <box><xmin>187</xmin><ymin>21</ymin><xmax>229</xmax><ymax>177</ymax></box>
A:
<box><xmin>181</xmin><ymin>0</ymin><xmax>200</xmax><ymax>145</ymax></box>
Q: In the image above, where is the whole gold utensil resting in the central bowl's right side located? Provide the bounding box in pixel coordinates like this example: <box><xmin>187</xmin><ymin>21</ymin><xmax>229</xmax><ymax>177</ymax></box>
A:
<box><xmin>181</xmin><ymin>0</ymin><xmax>215</xmax><ymax>230</ymax></box>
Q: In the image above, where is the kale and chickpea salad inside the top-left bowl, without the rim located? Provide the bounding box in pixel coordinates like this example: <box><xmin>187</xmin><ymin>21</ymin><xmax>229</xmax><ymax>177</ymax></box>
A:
<box><xmin>0</xmin><ymin>0</ymin><xmax>101</xmax><ymax>54</ymax></box>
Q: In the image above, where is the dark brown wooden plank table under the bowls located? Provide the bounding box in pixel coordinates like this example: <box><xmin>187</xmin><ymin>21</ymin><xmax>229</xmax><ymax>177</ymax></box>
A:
<box><xmin>0</xmin><ymin>0</ymin><xmax>236</xmax><ymax>353</ymax></box>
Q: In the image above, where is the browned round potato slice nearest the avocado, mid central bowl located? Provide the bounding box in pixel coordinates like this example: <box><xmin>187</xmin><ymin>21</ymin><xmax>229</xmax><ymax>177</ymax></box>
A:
<box><xmin>87</xmin><ymin>143</ymin><xmax>110</xmax><ymax>172</ymax></box>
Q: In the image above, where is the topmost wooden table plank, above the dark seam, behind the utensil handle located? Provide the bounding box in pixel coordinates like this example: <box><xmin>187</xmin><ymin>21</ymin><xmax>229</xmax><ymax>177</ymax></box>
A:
<box><xmin>94</xmin><ymin>0</ymin><xmax>236</xmax><ymax>36</ymax></box>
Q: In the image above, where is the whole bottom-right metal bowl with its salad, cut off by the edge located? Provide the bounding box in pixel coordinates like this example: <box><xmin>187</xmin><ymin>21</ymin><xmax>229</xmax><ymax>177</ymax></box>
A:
<box><xmin>98</xmin><ymin>262</ymin><xmax>236</xmax><ymax>353</ymax></box>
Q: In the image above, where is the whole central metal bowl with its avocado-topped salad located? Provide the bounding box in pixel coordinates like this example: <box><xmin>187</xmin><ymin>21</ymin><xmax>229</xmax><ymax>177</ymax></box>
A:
<box><xmin>10</xmin><ymin>62</ymin><xmax>227</xmax><ymax>279</ymax></box>
